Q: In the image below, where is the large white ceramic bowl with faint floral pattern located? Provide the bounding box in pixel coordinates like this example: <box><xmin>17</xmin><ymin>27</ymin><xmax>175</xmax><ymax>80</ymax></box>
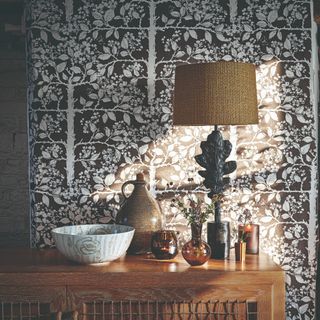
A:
<box><xmin>52</xmin><ymin>224</ymin><xmax>135</xmax><ymax>264</ymax></box>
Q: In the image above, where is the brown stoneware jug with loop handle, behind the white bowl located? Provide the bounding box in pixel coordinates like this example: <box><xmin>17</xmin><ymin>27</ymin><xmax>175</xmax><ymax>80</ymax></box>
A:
<box><xmin>116</xmin><ymin>173</ymin><xmax>162</xmax><ymax>254</ymax></box>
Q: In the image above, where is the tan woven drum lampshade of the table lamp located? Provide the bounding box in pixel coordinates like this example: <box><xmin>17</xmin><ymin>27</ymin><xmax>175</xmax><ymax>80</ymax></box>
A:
<box><xmin>173</xmin><ymin>61</ymin><xmax>258</xmax><ymax>126</ymax></box>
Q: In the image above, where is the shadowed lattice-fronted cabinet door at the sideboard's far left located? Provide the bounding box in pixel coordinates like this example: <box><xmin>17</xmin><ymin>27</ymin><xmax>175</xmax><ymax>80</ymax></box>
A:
<box><xmin>0</xmin><ymin>286</ymin><xmax>66</xmax><ymax>320</ymax></box>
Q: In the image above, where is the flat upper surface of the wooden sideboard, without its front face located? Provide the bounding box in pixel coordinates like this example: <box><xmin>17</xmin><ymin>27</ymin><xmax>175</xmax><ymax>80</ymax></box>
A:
<box><xmin>0</xmin><ymin>249</ymin><xmax>281</xmax><ymax>273</ymax></box>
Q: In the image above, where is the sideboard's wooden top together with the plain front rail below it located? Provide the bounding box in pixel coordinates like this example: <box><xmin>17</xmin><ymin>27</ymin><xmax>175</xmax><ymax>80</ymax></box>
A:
<box><xmin>0</xmin><ymin>249</ymin><xmax>284</xmax><ymax>289</ymax></box>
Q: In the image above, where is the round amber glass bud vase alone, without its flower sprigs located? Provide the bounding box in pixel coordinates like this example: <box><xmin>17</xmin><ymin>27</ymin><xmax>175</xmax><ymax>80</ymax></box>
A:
<box><xmin>181</xmin><ymin>223</ymin><xmax>211</xmax><ymax>266</ymax></box>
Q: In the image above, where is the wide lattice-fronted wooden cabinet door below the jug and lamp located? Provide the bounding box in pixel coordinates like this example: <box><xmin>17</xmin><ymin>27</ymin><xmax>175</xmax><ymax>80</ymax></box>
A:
<box><xmin>67</xmin><ymin>286</ymin><xmax>272</xmax><ymax>320</ymax></box>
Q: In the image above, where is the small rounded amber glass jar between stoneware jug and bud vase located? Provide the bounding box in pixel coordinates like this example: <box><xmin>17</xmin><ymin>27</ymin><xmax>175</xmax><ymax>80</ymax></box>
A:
<box><xmin>151</xmin><ymin>230</ymin><xmax>178</xmax><ymax>260</ymax></box>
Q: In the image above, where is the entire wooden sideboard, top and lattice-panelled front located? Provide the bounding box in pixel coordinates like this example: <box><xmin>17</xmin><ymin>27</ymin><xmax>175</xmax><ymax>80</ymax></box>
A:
<box><xmin>0</xmin><ymin>249</ymin><xmax>285</xmax><ymax>320</ymax></box>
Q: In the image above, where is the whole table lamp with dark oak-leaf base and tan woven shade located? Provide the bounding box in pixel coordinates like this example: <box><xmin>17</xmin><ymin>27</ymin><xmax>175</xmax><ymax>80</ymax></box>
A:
<box><xmin>173</xmin><ymin>61</ymin><xmax>258</xmax><ymax>259</ymax></box>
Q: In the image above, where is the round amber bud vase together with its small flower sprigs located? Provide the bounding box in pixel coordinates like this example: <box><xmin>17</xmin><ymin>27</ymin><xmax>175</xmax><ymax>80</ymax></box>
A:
<box><xmin>173</xmin><ymin>195</ymin><xmax>214</xmax><ymax>266</ymax></box>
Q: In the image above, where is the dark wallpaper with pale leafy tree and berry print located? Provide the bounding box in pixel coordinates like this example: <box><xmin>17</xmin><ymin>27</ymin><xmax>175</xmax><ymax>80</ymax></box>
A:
<box><xmin>27</xmin><ymin>0</ymin><xmax>317</xmax><ymax>320</ymax></box>
